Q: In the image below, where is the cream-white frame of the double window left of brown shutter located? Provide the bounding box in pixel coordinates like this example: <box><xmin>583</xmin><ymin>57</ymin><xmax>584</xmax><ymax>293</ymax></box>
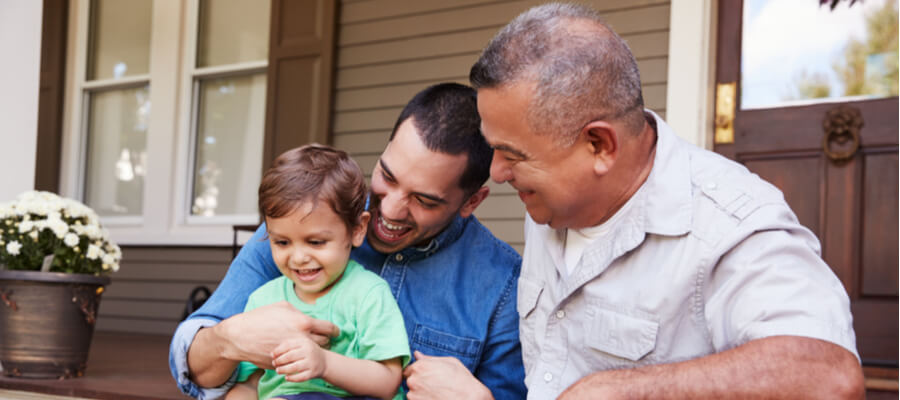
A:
<box><xmin>60</xmin><ymin>0</ymin><xmax>268</xmax><ymax>246</ymax></box>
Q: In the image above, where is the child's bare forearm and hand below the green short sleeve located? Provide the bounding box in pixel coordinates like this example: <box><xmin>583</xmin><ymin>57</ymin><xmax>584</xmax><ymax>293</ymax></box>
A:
<box><xmin>272</xmin><ymin>337</ymin><xmax>403</xmax><ymax>399</ymax></box>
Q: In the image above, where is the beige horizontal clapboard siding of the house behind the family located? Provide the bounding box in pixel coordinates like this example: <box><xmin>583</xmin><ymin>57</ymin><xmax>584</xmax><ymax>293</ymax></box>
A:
<box><xmin>97</xmin><ymin>0</ymin><xmax>669</xmax><ymax>334</ymax></box>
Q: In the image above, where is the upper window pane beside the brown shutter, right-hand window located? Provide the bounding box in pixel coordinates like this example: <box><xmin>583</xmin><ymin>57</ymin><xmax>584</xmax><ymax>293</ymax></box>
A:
<box><xmin>197</xmin><ymin>0</ymin><xmax>271</xmax><ymax>67</ymax></box>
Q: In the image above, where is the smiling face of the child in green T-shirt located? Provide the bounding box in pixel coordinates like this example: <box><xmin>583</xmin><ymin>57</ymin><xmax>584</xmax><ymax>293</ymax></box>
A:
<box><xmin>266</xmin><ymin>202</ymin><xmax>369</xmax><ymax>303</ymax></box>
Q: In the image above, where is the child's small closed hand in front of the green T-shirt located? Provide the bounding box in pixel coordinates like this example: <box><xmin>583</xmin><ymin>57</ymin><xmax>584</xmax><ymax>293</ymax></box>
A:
<box><xmin>272</xmin><ymin>336</ymin><xmax>327</xmax><ymax>382</ymax></box>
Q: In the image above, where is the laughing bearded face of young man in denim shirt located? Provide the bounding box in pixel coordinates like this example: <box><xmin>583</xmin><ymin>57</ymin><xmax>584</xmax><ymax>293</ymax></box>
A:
<box><xmin>367</xmin><ymin>118</ymin><xmax>474</xmax><ymax>253</ymax></box>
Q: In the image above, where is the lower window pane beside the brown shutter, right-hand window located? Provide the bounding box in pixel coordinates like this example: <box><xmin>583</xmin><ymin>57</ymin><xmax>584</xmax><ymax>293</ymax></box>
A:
<box><xmin>191</xmin><ymin>74</ymin><xmax>266</xmax><ymax>216</ymax></box>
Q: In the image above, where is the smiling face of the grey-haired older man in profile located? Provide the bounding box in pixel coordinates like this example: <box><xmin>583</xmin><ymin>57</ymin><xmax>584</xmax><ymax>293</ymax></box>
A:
<box><xmin>478</xmin><ymin>83</ymin><xmax>593</xmax><ymax>229</ymax></box>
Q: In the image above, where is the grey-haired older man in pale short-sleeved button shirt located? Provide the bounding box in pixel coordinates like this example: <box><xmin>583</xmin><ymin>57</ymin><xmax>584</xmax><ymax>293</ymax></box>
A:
<box><xmin>470</xmin><ymin>4</ymin><xmax>863</xmax><ymax>399</ymax></box>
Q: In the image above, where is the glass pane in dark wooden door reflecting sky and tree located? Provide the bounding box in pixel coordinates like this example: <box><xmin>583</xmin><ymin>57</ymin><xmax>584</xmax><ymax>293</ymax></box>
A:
<box><xmin>741</xmin><ymin>0</ymin><xmax>898</xmax><ymax>109</ymax></box>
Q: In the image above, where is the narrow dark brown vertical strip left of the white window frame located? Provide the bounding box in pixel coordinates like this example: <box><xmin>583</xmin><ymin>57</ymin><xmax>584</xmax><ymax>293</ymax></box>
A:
<box><xmin>34</xmin><ymin>0</ymin><xmax>69</xmax><ymax>193</ymax></box>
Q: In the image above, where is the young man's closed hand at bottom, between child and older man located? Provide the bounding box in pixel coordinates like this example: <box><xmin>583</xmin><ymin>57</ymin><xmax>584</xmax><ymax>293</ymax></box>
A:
<box><xmin>403</xmin><ymin>351</ymin><xmax>493</xmax><ymax>400</ymax></box>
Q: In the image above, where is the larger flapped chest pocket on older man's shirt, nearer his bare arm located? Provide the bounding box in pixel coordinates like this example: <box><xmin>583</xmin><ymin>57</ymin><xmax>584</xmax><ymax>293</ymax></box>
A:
<box><xmin>585</xmin><ymin>309</ymin><xmax>659</xmax><ymax>362</ymax></box>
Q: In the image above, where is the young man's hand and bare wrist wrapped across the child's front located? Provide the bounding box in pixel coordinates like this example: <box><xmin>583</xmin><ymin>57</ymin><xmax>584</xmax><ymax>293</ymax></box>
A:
<box><xmin>188</xmin><ymin>301</ymin><xmax>340</xmax><ymax>387</ymax></box>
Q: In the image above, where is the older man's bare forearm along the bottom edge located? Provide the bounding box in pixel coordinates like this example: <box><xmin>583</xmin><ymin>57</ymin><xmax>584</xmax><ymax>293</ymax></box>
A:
<box><xmin>559</xmin><ymin>336</ymin><xmax>865</xmax><ymax>400</ymax></box>
